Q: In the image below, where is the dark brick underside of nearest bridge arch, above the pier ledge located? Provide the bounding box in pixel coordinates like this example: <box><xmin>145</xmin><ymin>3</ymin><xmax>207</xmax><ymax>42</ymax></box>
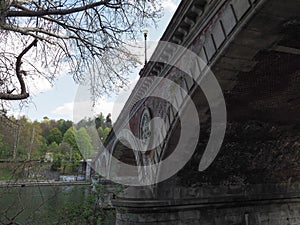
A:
<box><xmin>178</xmin><ymin>1</ymin><xmax>300</xmax><ymax>186</ymax></box>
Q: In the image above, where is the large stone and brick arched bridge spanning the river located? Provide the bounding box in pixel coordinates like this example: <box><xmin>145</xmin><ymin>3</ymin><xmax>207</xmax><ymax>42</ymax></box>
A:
<box><xmin>95</xmin><ymin>0</ymin><xmax>300</xmax><ymax>225</ymax></box>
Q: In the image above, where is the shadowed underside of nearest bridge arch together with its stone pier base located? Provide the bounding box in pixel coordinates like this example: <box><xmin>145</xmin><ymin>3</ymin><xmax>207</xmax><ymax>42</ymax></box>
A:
<box><xmin>111</xmin><ymin>0</ymin><xmax>300</xmax><ymax>225</ymax></box>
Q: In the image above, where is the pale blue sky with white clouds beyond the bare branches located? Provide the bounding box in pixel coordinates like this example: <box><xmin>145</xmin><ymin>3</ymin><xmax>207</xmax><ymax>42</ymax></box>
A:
<box><xmin>9</xmin><ymin>0</ymin><xmax>180</xmax><ymax>121</ymax></box>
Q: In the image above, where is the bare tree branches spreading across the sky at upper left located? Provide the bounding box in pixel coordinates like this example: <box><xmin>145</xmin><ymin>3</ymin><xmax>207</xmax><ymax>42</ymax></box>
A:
<box><xmin>0</xmin><ymin>0</ymin><xmax>161</xmax><ymax>100</ymax></box>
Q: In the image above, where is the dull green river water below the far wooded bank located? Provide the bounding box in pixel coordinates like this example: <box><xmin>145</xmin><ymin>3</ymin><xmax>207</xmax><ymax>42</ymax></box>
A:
<box><xmin>0</xmin><ymin>185</ymin><xmax>94</xmax><ymax>225</ymax></box>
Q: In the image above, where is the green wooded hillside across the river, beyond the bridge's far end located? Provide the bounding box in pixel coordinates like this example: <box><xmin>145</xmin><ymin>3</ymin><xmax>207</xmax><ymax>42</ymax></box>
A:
<box><xmin>0</xmin><ymin>113</ymin><xmax>112</xmax><ymax>176</ymax></box>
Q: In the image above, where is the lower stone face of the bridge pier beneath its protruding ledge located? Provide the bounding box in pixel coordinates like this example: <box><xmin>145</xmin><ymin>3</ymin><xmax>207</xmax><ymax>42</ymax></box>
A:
<box><xmin>116</xmin><ymin>199</ymin><xmax>300</xmax><ymax>225</ymax></box>
